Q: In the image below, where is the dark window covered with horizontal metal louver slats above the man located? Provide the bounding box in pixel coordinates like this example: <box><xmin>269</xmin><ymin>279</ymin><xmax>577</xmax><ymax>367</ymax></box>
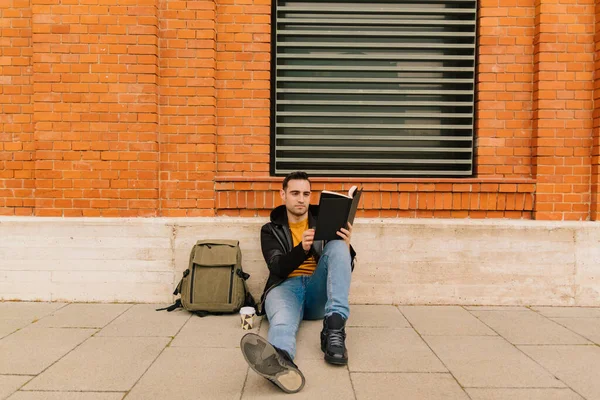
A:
<box><xmin>271</xmin><ymin>0</ymin><xmax>477</xmax><ymax>176</ymax></box>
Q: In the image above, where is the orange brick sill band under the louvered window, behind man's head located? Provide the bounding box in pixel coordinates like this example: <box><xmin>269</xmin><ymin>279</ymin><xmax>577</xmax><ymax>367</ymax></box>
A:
<box><xmin>217</xmin><ymin>177</ymin><xmax>534</xmax><ymax>219</ymax></box>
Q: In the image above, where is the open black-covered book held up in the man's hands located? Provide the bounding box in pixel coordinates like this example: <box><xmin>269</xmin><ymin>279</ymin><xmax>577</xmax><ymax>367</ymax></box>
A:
<box><xmin>315</xmin><ymin>186</ymin><xmax>362</xmax><ymax>240</ymax></box>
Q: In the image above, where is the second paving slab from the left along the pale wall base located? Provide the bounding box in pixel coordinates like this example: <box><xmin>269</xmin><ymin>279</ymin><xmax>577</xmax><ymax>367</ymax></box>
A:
<box><xmin>37</xmin><ymin>303</ymin><xmax>132</xmax><ymax>328</ymax></box>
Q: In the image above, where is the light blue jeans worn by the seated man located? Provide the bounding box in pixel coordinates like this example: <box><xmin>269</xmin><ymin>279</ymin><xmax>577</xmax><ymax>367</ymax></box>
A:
<box><xmin>265</xmin><ymin>240</ymin><xmax>352</xmax><ymax>359</ymax></box>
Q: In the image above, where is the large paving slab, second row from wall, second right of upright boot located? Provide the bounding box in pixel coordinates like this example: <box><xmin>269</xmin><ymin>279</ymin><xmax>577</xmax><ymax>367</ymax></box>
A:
<box><xmin>423</xmin><ymin>336</ymin><xmax>565</xmax><ymax>388</ymax></box>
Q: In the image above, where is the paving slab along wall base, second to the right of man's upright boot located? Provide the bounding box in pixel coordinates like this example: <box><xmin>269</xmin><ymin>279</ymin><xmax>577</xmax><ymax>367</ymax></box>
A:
<box><xmin>400</xmin><ymin>306</ymin><xmax>496</xmax><ymax>336</ymax></box>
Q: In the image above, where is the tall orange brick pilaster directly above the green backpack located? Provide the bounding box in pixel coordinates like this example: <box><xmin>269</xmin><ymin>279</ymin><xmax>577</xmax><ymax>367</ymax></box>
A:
<box><xmin>157</xmin><ymin>0</ymin><xmax>217</xmax><ymax>216</ymax></box>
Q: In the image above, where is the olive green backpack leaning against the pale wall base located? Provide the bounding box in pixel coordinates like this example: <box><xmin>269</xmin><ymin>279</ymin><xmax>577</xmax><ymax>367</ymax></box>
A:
<box><xmin>157</xmin><ymin>240</ymin><xmax>256</xmax><ymax>317</ymax></box>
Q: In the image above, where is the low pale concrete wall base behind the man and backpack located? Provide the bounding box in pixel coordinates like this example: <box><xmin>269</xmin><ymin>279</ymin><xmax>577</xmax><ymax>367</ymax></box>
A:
<box><xmin>0</xmin><ymin>217</ymin><xmax>600</xmax><ymax>306</ymax></box>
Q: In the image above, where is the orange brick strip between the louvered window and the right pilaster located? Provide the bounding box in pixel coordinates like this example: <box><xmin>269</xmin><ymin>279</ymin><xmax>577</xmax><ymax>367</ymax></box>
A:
<box><xmin>475</xmin><ymin>0</ymin><xmax>535</xmax><ymax>178</ymax></box>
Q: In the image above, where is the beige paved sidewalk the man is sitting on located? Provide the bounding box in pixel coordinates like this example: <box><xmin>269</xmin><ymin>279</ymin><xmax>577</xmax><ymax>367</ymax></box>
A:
<box><xmin>0</xmin><ymin>302</ymin><xmax>600</xmax><ymax>400</ymax></box>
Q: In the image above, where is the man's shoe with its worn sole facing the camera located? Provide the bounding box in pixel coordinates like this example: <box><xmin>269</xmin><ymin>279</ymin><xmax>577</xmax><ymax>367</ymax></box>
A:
<box><xmin>240</xmin><ymin>333</ymin><xmax>304</xmax><ymax>393</ymax></box>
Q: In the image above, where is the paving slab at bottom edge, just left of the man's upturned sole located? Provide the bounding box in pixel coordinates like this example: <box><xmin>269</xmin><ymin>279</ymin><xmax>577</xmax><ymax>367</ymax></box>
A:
<box><xmin>127</xmin><ymin>347</ymin><xmax>248</xmax><ymax>400</ymax></box>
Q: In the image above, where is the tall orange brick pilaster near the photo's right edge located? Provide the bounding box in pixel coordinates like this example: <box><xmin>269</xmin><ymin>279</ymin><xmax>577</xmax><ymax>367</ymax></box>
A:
<box><xmin>534</xmin><ymin>0</ymin><xmax>595</xmax><ymax>220</ymax></box>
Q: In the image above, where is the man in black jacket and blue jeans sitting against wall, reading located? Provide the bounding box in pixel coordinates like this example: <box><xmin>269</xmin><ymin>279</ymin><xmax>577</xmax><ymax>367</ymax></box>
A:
<box><xmin>241</xmin><ymin>171</ymin><xmax>356</xmax><ymax>393</ymax></box>
